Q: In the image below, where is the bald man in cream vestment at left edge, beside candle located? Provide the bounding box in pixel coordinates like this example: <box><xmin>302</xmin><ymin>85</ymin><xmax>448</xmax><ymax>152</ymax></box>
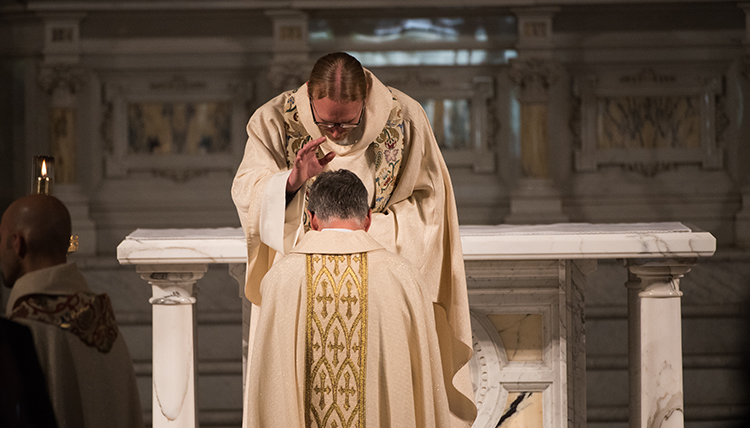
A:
<box><xmin>0</xmin><ymin>195</ymin><xmax>143</xmax><ymax>428</ymax></box>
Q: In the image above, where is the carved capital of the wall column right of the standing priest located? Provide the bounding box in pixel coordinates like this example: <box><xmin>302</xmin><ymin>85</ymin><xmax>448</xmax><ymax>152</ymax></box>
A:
<box><xmin>508</xmin><ymin>58</ymin><xmax>563</xmax><ymax>103</ymax></box>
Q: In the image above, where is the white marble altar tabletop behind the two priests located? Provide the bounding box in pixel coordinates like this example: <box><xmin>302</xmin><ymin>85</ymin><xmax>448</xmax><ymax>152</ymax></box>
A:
<box><xmin>117</xmin><ymin>223</ymin><xmax>716</xmax><ymax>264</ymax></box>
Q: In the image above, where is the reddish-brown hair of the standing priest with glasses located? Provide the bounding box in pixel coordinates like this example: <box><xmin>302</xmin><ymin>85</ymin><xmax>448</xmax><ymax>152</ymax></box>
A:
<box><xmin>307</xmin><ymin>52</ymin><xmax>367</xmax><ymax>102</ymax></box>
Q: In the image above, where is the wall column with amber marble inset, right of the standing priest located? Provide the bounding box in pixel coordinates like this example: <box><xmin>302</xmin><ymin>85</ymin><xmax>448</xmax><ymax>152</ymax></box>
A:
<box><xmin>505</xmin><ymin>59</ymin><xmax>568</xmax><ymax>223</ymax></box>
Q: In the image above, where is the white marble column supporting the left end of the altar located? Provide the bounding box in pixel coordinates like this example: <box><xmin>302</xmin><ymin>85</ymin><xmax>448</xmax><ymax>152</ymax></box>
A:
<box><xmin>136</xmin><ymin>264</ymin><xmax>208</xmax><ymax>428</ymax></box>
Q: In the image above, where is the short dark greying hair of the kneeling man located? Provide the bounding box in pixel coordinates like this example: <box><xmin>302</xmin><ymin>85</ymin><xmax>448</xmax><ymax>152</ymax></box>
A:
<box><xmin>307</xmin><ymin>169</ymin><xmax>370</xmax><ymax>221</ymax></box>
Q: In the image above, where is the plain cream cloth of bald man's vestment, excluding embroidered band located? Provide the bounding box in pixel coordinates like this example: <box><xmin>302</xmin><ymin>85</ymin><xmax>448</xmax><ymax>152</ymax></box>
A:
<box><xmin>6</xmin><ymin>264</ymin><xmax>144</xmax><ymax>428</ymax></box>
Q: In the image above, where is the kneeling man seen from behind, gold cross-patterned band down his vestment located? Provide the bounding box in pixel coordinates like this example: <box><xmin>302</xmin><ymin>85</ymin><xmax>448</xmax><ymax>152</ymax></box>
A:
<box><xmin>243</xmin><ymin>170</ymin><xmax>451</xmax><ymax>428</ymax></box>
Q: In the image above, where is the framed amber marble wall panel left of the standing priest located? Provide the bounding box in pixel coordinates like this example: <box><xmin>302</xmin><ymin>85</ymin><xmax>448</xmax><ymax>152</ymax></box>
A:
<box><xmin>101</xmin><ymin>73</ymin><xmax>251</xmax><ymax>182</ymax></box>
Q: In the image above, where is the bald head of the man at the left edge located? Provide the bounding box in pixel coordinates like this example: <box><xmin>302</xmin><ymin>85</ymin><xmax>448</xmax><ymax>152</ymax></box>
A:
<box><xmin>0</xmin><ymin>195</ymin><xmax>71</xmax><ymax>287</ymax></box>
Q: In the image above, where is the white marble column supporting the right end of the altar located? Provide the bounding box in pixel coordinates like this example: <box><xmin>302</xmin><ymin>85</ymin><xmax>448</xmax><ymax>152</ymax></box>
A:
<box><xmin>626</xmin><ymin>259</ymin><xmax>695</xmax><ymax>428</ymax></box>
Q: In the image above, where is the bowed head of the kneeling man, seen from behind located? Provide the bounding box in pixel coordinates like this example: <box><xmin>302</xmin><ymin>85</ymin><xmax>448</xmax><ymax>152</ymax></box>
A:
<box><xmin>307</xmin><ymin>169</ymin><xmax>371</xmax><ymax>231</ymax></box>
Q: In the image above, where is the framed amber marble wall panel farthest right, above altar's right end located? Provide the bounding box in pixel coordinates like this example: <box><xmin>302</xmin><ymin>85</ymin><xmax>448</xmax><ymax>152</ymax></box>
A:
<box><xmin>570</xmin><ymin>68</ymin><xmax>728</xmax><ymax>176</ymax></box>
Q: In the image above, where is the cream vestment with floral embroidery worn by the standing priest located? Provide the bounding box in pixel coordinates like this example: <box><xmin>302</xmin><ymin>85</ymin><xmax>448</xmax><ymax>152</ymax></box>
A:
<box><xmin>232</xmin><ymin>71</ymin><xmax>476</xmax><ymax>426</ymax></box>
